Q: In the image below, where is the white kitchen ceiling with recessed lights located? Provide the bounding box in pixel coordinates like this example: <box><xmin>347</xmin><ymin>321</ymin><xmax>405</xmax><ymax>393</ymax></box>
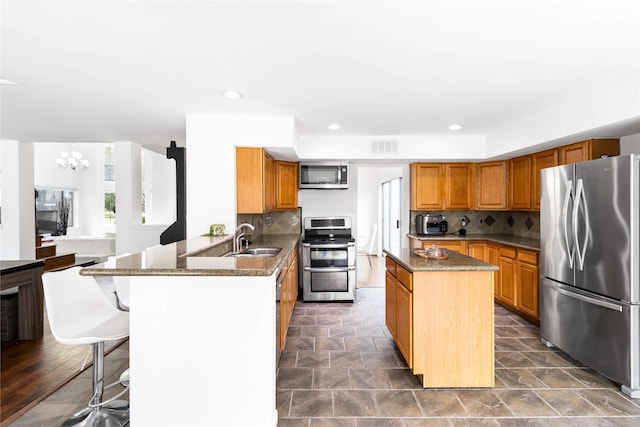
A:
<box><xmin>0</xmin><ymin>0</ymin><xmax>640</xmax><ymax>152</ymax></box>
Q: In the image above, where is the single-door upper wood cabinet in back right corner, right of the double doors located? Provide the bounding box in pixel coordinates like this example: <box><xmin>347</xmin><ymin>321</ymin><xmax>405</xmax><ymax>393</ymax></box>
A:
<box><xmin>475</xmin><ymin>160</ymin><xmax>509</xmax><ymax>210</ymax></box>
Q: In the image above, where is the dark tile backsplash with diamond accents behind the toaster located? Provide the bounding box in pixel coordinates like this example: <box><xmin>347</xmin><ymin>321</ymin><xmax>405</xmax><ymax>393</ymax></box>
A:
<box><xmin>410</xmin><ymin>211</ymin><xmax>540</xmax><ymax>239</ymax></box>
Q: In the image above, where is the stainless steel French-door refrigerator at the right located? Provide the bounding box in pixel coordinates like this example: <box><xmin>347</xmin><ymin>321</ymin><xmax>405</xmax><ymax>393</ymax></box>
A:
<box><xmin>540</xmin><ymin>155</ymin><xmax>640</xmax><ymax>398</ymax></box>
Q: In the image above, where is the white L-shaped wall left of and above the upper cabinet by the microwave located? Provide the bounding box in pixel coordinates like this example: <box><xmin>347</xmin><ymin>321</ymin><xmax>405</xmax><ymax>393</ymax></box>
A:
<box><xmin>186</xmin><ymin>115</ymin><xmax>296</xmax><ymax>237</ymax></box>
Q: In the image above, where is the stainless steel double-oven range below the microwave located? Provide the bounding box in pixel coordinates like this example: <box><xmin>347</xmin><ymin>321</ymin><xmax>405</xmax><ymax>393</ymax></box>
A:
<box><xmin>302</xmin><ymin>217</ymin><xmax>356</xmax><ymax>301</ymax></box>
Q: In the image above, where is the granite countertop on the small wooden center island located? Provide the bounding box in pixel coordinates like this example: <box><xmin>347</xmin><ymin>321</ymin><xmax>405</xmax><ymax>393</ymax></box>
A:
<box><xmin>384</xmin><ymin>248</ymin><xmax>499</xmax><ymax>273</ymax></box>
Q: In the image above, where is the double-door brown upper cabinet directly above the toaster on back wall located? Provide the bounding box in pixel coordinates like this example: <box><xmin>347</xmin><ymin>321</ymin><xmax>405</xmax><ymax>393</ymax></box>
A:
<box><xmin>410</xmin><ymin>163</ymin><xmax>474</xmax><ymax>210</ymax></box>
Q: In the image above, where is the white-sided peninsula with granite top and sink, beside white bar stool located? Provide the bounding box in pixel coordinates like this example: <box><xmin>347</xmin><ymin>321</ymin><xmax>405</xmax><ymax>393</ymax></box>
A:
<box><xmin>81</xmin><ymin>234</ymin><xmax>300</xmax><ymax>427</ymax></box>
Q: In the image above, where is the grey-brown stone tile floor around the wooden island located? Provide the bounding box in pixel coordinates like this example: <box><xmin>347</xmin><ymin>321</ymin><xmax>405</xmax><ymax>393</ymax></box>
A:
<box><xmin>277</xmin><ymin>288</ymin><xmax>640</xmax><ymax>427</ymax></box>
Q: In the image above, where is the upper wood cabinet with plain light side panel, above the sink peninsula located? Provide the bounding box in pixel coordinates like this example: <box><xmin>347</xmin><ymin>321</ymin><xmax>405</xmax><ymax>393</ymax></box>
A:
<box><xmin>236</xmin><ymin>147</ymin><xmax>275</xmax><ymax>214</ymax></box>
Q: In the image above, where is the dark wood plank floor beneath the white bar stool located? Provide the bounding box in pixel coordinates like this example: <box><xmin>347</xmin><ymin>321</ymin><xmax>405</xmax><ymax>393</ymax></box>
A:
<box><xmin>0</xmin><ymin>313</ymin><xmax>126</xmax><ymax>427</ymax></box>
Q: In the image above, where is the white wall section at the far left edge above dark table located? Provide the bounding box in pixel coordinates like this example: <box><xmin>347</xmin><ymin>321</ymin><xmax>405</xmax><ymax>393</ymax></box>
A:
<box><xmin>0</xmin><ymin>141</ymin><xmax>36</xmax><ymax>260</ymax></box>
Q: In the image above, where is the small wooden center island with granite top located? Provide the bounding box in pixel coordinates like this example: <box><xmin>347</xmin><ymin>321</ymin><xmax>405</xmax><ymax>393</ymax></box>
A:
<box><xmin>384</xmin><ymin>248</ymin><xmax>498</xmax><ymax>388</ymax></box>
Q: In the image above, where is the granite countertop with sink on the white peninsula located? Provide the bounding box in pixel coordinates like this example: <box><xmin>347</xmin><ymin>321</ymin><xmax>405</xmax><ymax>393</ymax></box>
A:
<box><xmin>80</xmin><ymin>234</ymin><xmax>300</xmax><ymax>276</ymax></box>
